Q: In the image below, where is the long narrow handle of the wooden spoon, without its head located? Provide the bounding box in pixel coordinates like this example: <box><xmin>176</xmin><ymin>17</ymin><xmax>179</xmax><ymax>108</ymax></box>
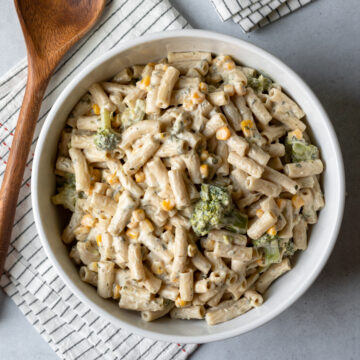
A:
<box><xmin>0</xmin><ymin>73</ymin><xmax>48</xmax><ymax>276</ymax></box>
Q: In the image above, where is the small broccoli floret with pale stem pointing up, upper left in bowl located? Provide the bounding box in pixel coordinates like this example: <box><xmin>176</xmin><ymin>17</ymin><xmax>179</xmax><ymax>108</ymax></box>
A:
<box><xmin>94</xmin><ymin>109</ymin><xmax>120</xmax><ymax>151</ymax></box>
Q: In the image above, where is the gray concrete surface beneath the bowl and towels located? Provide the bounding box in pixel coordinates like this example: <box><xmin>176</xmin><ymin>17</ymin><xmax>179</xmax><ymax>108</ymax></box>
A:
<box><xmin>0</xmin><ymin>0</ymin><xmax>360</xmax><ymax>360</ymax></box>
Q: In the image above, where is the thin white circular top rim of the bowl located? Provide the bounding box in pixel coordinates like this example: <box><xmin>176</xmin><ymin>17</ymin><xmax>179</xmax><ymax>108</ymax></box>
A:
<box><xmin>31</xmin><ymin>29</ymin><xmax>345</xmax><ymax>343</ymax></box>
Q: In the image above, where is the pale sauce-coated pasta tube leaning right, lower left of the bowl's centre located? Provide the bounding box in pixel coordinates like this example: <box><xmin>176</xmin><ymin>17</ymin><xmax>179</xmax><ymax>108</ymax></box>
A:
<box><xmin>108</xmin><ymin>191</ymin><xmax>138</xmax><ymax>235</ymax></box>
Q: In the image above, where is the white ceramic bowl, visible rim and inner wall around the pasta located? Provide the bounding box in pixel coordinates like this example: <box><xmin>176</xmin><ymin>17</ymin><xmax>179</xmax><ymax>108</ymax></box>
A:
<box><xmin>31</xmin><ymin>30</ymin><xmax>344</xmax><ymax>343</ymax></box>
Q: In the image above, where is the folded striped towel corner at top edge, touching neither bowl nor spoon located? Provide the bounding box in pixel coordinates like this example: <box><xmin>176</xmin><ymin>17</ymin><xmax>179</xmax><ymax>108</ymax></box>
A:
<box><xmin>211</xmin><ymin>0</ymin><xmax>313</xmax><ymax>32</ymax></box>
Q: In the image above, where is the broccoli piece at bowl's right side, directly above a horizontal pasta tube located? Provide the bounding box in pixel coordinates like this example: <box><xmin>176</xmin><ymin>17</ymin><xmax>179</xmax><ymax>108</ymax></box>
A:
<box><xmin>285</xmin><ymin>135</ymin><xmax>319</xmax><ymax>162</ymax></box>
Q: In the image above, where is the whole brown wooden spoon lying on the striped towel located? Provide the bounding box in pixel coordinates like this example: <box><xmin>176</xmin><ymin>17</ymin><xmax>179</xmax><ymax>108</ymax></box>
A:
<box><xmin>0</xmin><ymin>0</ymin><xmax>105</xmax><ymax>276</ymax></box>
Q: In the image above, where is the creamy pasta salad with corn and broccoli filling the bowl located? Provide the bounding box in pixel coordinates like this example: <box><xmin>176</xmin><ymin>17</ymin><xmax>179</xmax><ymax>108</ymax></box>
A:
<box><xmin>52</xmin><ymin>52</ymin><xmax>324</xmax><ymax>325</ymax></box>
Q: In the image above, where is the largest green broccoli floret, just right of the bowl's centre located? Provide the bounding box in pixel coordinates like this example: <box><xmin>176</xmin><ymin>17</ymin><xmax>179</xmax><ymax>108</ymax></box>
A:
<box><xmin>190</xmin><ymin>184</ymin><xmax>247</xmax><ymax>236</ymax></box>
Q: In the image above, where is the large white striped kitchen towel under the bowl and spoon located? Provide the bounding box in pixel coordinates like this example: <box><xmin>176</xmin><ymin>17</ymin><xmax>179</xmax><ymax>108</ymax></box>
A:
<box><xmin>0</xmin><ymin>0</ymin><xmax>197</xmax><ymax>360</ymax></box>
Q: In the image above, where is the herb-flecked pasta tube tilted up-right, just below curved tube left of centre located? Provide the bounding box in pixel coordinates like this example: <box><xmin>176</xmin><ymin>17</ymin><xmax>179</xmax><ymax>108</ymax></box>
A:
<box><xmin>124</xmin><ymin>136</ymin><xmax>160</xmax><ymax>175</ymax></box>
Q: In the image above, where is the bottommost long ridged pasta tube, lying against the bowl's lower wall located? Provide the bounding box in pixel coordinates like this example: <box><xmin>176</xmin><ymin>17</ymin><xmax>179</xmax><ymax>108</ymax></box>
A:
<box><xmin>205</xmin><ymin>298</ymin><xmax>252</xmax><ymax>325</ymax></box>
